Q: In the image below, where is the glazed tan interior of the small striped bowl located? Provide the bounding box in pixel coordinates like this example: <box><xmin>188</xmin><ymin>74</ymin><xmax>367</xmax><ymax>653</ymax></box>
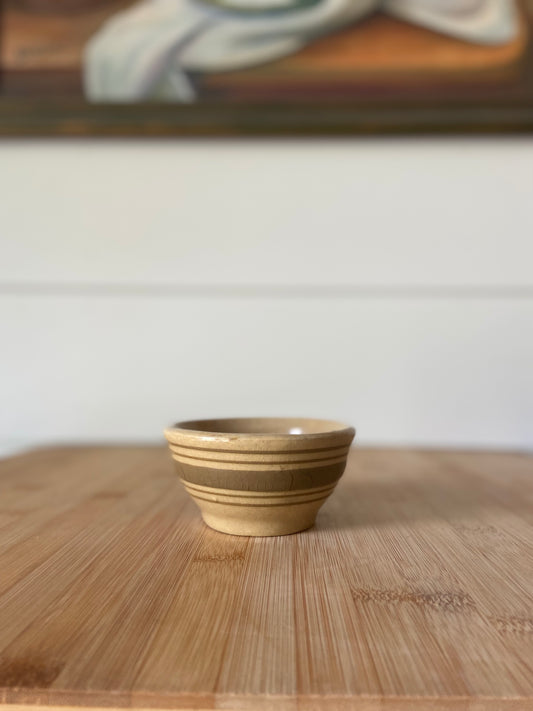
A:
<box><xmin>176</xmin><ymin>417</ymin><xmax>351</xmax><ymax>436</ymax></box>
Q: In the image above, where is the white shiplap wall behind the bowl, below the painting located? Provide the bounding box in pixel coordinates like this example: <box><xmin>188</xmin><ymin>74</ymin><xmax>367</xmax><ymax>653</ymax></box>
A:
<box><xmin>0</xmin><ymin>138</ymin><xmax>533</xmax><ymax>451</ymax></box>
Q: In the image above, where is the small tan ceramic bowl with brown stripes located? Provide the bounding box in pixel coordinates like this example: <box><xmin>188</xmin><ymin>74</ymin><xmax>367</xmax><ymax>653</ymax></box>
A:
<box><xmin>165</xmin><ymin>417</ymin><xmax>355</xmax><ymax>536</ymax></box>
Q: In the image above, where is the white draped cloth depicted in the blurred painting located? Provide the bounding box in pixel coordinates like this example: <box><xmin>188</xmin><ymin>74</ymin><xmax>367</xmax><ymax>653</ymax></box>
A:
<box><xmin>84</xmin><ymin>0</ymin><xmax>518</xmax><ymax>102</ymax></box>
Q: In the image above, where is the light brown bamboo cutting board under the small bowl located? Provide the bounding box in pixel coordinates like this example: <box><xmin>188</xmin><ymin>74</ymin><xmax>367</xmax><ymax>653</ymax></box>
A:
<box><xmin>0</xmin><ymin>447</ymin><xmax>533</xmax><ymax>711</ymax></box>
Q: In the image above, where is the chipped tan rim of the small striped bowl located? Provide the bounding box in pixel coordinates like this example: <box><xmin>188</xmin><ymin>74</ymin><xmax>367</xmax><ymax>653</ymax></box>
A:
<box><xmin>165</xmin><ymin>417</ymin><xmax>356</xmax><ymax>441</ymax></box>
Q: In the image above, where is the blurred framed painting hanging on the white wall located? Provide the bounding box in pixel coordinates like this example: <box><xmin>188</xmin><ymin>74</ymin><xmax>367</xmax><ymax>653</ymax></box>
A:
<box><xmin>0</xmin><ymin>0</ymin><xmax>533</xmax><ymax>135</ymax></box>
